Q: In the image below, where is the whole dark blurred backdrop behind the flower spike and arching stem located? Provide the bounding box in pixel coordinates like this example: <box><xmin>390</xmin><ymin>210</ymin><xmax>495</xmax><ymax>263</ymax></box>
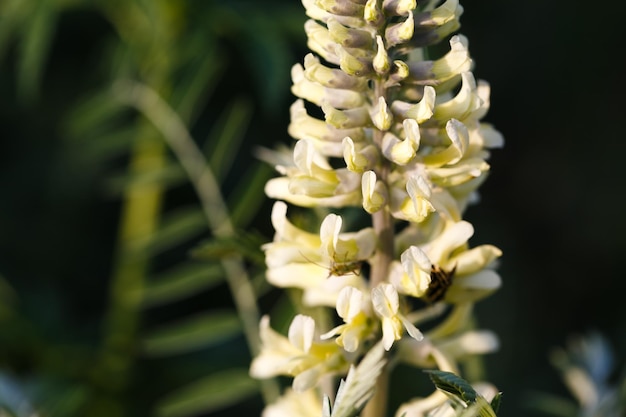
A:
<box><xmin>0</xmin><ymin>0</ymin><xmax>626</xmax><ymax>417</ymax></box>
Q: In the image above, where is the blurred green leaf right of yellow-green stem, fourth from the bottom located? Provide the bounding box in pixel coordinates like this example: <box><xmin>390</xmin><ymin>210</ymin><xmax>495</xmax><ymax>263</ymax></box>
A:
<box><xmin>142</xmin><ymin>206</ymin><xmax>207</xmax><ymax>255</ymax></box>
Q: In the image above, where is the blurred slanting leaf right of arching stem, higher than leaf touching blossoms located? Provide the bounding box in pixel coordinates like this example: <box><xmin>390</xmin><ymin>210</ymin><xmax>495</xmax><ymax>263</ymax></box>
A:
<box><xmin>207</xmin><ymin>97</ymin><xmax>252</xmax><ymax>180</ymax></box>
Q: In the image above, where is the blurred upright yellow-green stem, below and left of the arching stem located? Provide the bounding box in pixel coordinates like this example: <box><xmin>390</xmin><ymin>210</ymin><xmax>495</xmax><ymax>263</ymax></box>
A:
<box><xmin>94</xmin><ymin>125</ymin><xmax>165</xmax><ymax>417</ymax></box>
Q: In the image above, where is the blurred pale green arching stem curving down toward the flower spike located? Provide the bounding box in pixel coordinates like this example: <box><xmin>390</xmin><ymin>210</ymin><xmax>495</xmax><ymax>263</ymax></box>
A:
<box><xmin>114</xmin><ymin>81</ymin><xmax>279</xmax><ymax>402</ymax></box>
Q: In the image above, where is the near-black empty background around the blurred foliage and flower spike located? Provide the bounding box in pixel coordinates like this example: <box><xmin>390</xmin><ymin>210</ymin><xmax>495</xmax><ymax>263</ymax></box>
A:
<box><xmin>0</xmin><ymin>0</ymin><xmax>626</xmax><ymax>416</ymax></box>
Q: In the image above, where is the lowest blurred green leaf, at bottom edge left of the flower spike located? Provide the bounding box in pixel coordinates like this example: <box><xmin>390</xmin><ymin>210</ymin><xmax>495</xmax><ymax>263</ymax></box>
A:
<box><xmin>156</xmin><ymin>369</ymin><xmax>258</xmax><ymax>417</ymax></box>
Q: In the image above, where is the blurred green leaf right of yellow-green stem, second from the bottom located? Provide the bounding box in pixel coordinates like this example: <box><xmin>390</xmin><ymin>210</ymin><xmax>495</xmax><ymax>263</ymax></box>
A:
<box><xmin>143</xmin><ymin>311</ymin><xmax>241</xmax><ymax>356</ymax></box>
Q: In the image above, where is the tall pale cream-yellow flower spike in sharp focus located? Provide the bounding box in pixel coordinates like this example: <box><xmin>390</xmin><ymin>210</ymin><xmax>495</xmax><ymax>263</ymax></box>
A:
<box><xmin>251</xmin><ymin>0</ymin><xmax>503</xmax><ymax>416</ymax></box>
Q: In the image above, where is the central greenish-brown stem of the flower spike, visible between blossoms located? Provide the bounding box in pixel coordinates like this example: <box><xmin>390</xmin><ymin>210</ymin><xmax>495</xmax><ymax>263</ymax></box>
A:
<box><xmin>361</xmin><ymin>81</ymin><xmax>394</xmax><ymax>417</ymax></box>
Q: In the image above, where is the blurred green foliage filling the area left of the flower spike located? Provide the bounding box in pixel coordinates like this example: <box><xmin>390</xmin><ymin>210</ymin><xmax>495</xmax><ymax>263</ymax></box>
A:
<box><xmin>0</xmin><ymin>0</ymin><xmax>304</xmax><ymax>417</ymax></box>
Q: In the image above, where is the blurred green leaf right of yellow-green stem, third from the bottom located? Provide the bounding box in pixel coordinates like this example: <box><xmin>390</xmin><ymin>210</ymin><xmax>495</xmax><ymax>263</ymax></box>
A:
<box><xmin>143</xmin><ymin>262</ymin><xmax>224</xmax><ymax>307</ymax></box>
